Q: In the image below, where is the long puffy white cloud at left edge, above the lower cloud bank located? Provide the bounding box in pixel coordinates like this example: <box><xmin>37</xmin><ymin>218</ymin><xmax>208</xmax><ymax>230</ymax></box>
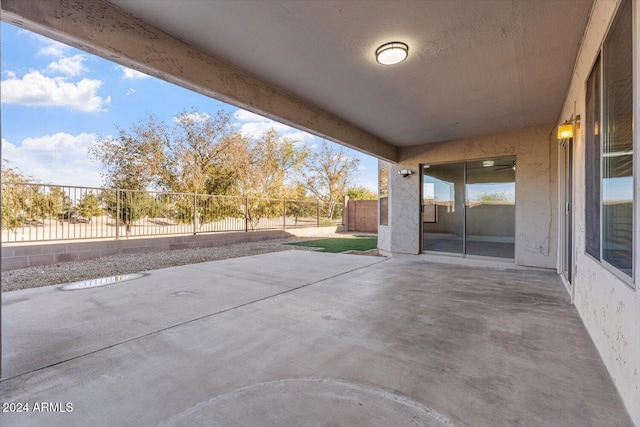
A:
<box><xmin>0</xmin><ymin>71</ymin><xmax>111</xmax><ymax>112</ymax></box>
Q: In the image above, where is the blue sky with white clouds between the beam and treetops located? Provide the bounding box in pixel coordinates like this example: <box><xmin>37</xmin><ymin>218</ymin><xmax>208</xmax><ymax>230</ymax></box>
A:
<box><xmin>0</xmin><ymin>22</ymin><xmax>378</xmax><ymax>191</ymax></box>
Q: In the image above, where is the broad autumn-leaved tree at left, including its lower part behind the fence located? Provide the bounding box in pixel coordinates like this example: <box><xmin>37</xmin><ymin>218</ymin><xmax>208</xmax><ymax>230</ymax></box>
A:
<box><xmin>91</xmin><ymin>111</ymin><xmax>245</xmax><ymax>230</ymax></box>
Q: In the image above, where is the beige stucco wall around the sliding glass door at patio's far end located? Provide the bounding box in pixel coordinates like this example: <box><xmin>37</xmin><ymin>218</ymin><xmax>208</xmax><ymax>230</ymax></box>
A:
<box><xmin>382</xmin><ymin>125</ymin><xmax>558</xmax><ymax>268</ymax></box>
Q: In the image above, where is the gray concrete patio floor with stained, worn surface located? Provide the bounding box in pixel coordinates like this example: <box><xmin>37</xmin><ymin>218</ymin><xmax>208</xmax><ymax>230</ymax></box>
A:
<box><xmin>0</xmin><ymin>251</ymin><xmax>632</xmax><ymax>427</ymax></box>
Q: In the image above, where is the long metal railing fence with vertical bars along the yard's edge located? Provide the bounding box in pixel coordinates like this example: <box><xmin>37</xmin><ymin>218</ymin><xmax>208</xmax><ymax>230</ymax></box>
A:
<box><xmin>2</xmin><ymin>183</ymin><xmax>343</xmax><ymax>242</ymax></box>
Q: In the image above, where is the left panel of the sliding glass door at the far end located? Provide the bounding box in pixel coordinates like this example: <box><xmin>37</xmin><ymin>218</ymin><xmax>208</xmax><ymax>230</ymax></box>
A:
<box><xmin>422</xmin><ymin>163</ymin><xmax>464</xmax><ymax>254</ymax></box>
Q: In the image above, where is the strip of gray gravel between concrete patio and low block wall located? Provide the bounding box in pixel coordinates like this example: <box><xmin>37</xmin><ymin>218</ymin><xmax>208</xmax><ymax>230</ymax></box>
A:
<box><xmin>2</xmin><ymin>234</ymin><xmax>332</xmax><ymax>292</ymax></box>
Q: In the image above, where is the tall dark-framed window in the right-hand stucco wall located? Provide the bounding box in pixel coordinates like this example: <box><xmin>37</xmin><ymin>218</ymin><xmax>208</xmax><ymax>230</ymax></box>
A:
<box><xmin>585</xmin><ymin>0</ymin><xmax>634</xmax><ymax>278</ymax></box>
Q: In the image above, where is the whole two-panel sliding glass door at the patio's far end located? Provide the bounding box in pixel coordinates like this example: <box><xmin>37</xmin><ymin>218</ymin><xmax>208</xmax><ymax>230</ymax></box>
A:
<box><xmin>422</xmin><ymin>158</ymin><xmax>516</xmax><ymax>258</ymax></box>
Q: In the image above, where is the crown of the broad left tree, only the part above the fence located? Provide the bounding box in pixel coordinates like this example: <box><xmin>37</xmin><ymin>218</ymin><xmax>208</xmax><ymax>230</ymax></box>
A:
<box><xmin>90</xmin><ymin>111</ymin><xmax>236</xmax><ymax>194</ymax></box>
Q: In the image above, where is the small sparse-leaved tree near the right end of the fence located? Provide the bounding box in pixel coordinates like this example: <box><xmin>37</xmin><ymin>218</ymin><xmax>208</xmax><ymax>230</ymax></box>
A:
<box><xmin>300</xmin><ymin>141</ymin><xmax>360</xmax><ymax>220</ymax></box>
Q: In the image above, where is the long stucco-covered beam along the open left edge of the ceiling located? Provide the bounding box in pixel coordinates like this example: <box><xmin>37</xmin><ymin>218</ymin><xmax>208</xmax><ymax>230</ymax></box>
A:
<box><xmin>0</xmin><ymin>0</ymin><xmax>398</xmax><ymax>162</ymax></box>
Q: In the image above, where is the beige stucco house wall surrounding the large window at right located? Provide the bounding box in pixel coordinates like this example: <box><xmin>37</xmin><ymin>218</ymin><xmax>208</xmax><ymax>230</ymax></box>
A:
<box><xmin>558</xmin><ymin>0</ymin><xmax>640</xmax><ymax>425</ymax></box>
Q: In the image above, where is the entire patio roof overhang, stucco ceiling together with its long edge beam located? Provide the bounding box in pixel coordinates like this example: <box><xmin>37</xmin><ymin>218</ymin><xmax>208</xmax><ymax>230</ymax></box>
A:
<box><xmin>1</xmin><ymin>0</ymin><xmax>593</xmax><ymax>162</ymax></box>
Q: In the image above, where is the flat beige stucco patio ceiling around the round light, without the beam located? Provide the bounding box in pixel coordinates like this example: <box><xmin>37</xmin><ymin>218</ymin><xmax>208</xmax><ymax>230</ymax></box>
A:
<box><xmin>106</xmin><ymin>0</ymin><xmax>592</xmax><ymax>146</ymax></box>
